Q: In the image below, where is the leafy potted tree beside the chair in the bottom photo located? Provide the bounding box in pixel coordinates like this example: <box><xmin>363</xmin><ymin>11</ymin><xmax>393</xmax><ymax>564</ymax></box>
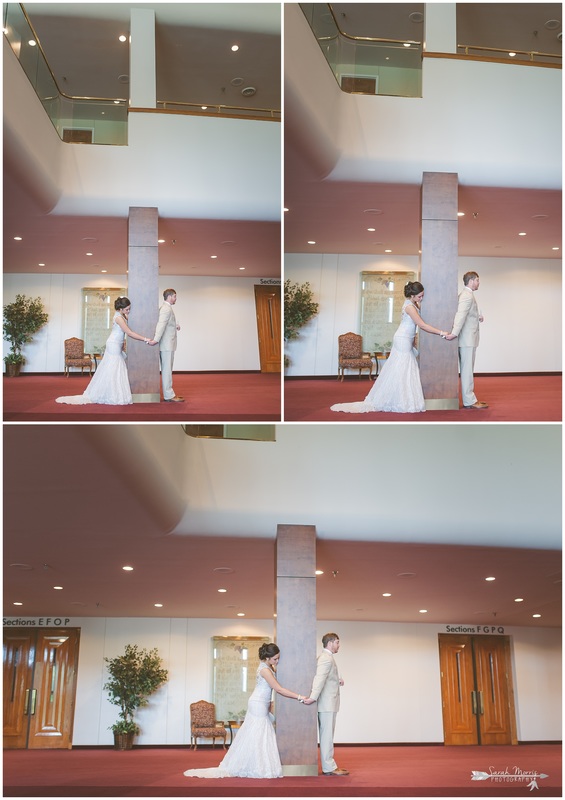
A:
<box><xmin>104</xmin><ymin>644</ymin><xmax>168</xmax><ymax>750</ymax></box>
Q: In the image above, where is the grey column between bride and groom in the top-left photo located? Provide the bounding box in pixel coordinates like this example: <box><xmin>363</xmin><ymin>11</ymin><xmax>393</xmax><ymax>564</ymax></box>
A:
<box><xmin>127</xmin><ymin>208</ymin><xmax>160</xmax><ymax>403</ymax></box>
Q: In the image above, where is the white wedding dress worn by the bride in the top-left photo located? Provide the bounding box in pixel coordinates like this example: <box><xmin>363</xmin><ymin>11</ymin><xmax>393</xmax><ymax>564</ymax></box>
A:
<box><xmin>56</xmin><ymin>314</ymin><xmax>133</xmax><ymax>406</ymax></box>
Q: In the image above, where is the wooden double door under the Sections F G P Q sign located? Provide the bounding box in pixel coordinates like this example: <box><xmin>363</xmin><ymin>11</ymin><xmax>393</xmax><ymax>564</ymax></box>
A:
<box><xmin>439</xmin><ymin>634</ymin><xmax>518</xmax><ymax>745</ymax></box>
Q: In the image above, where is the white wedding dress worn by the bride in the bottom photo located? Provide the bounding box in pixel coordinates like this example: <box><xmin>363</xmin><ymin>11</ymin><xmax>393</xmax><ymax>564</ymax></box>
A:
<box><xmin>184</xmin><ymin>662</ymin><xmax>283</xmax><ymax>778</ymax></box>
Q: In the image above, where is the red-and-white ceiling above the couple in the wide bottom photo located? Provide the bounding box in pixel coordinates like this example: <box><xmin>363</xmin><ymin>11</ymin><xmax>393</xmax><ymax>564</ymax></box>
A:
<box><xmin>4</xmin><ymin>424</ymin><xmax>561</xmax><ymax>626</ymax></box>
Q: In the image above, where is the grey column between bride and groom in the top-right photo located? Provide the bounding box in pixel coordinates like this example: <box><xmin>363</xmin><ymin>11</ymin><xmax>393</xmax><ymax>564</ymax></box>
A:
<box><xmin>419</xmin><ymin>172</ymin><xmax>459</xmax><ymax>409</ymax></box>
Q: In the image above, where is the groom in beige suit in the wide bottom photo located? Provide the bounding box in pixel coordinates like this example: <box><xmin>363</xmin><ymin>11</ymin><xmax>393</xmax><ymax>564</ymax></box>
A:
<box><xmin>310</xmin><ymin>633</ymin><xmax>349</xmax><ymax>775</ymax></box>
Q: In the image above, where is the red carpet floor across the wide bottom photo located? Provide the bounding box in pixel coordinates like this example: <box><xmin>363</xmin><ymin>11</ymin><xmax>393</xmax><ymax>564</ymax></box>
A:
<box><xmin>4</xmin><ymin>744</ymin><xmax>561</xmax><ymax>798</ymax></box>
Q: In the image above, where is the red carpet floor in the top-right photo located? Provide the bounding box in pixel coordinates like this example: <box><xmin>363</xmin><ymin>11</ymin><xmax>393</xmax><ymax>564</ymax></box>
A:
<box><xmin>284</xmin><ymin>375</ymin><xmax>562</xmax><ymax>422</ymax></box>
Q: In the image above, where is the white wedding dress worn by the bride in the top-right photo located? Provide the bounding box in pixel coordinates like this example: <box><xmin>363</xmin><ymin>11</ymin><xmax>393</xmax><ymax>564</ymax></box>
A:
<box><xmin>331</xmin><ymin>300</ymin><xmax>426</xmax><ymax>414</ymax></box>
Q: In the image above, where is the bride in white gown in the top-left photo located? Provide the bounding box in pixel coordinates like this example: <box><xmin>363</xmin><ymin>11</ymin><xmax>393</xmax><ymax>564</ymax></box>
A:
<box><xmin>56</xmin><ymin>297</ymin><xmax>157</xmax><ymax>406</ymax></box>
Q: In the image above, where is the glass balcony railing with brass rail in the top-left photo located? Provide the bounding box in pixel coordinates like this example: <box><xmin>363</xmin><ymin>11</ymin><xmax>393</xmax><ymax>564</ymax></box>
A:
<box><xmin>4</xmin><ymin>3</ymin><xmax>281</xmax><ymax>145</ymax></box>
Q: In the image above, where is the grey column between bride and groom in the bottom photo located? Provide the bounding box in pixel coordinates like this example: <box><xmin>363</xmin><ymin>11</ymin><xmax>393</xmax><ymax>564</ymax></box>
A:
<box><xmin>276</xmin><ymin>525</ymin><xmax>318</xmax><ymax>775</ymax></box>
